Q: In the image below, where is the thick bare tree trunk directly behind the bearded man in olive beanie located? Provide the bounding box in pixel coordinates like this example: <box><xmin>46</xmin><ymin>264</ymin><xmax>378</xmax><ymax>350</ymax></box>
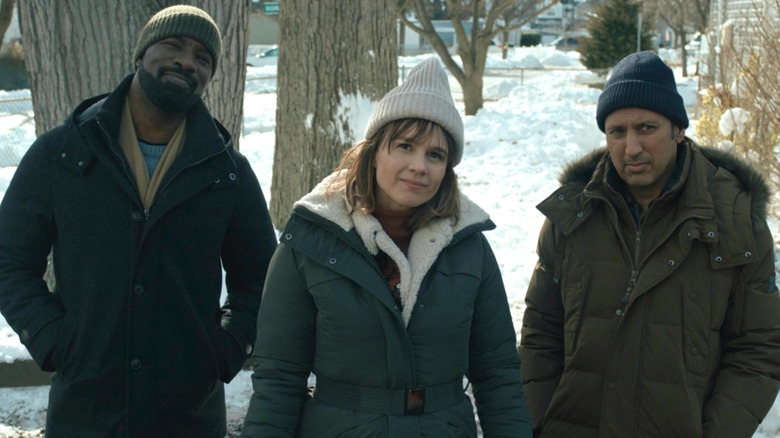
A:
<box><xmin>17</xmin><ymin>0</ymin><xmax>249</xmax><ymax>288</ymax></box>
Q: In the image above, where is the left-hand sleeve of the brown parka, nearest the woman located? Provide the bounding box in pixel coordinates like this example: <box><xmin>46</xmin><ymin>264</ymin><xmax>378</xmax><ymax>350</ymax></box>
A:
<box><xmin>519</xmin><ymin>220</ymin><xmax>564</xmax><ymax>431</ymax></box>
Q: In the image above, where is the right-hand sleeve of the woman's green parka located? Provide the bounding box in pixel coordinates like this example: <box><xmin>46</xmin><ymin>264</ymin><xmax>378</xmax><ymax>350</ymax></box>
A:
<box><xmin>468</xmin><ymin>236</ymin><xmax>531</xmax><ymax>438</ymax></box>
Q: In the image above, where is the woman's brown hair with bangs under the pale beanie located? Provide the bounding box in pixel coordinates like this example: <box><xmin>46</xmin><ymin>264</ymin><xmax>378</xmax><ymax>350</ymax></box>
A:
<box><xmin>326</xmin><ymin>119</ymin><xmax>460</xmax><ymax>230</ymax></box>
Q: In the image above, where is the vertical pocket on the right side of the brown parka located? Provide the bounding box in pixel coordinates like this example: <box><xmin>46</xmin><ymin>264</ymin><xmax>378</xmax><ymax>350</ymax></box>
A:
<box><xmin>680</xmin><ymin>276</ymin><xmax>712</xmax><ymax>376</ymax></box>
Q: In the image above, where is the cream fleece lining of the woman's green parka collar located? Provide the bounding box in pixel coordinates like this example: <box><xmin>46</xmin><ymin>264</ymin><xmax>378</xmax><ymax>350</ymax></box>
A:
<box><xmin>293</xmin><ymin>172</ymin><xmax>495</xmax><ymax>325</ymax></box>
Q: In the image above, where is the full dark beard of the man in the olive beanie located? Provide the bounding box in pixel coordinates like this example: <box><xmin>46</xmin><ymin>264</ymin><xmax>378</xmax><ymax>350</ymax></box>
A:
<box><xmin>138</xmin><ymin>66</ymin><xmax>200</xmax><ymax>114</ymax></box>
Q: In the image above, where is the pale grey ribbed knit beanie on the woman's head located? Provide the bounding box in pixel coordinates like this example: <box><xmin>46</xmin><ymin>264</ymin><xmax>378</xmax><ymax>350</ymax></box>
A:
<box><xmin>365</xmin><ymin>58</ymin><xmax>463</xmax><ymax>165</ymax></box>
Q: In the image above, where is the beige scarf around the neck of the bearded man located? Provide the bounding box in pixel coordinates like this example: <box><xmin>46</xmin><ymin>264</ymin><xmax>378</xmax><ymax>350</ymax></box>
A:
<box><xmin>119</xmin><ymin>99</ymin><xmax>187</xmax><ymax>210</ymax></box>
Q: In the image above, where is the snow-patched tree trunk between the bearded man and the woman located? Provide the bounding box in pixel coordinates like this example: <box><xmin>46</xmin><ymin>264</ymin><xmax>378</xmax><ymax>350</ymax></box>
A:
<box><xmin>270</xmin><ymin>0</ymin><xmax>398</xmax><ymax>229</ymax></box>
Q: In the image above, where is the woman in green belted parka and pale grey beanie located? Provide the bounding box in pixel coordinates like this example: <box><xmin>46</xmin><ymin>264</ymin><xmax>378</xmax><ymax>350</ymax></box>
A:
<box><xmin>242</xmin><ymin>58</ymin><xmax>531</xmax><ymax>438</ymax></box>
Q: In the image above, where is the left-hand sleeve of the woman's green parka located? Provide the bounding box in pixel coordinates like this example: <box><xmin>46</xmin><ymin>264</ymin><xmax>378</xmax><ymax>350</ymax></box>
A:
<box><xmin>241</xmin><ymin>245</ymin><xmax>317</xmax><ymax>438</ymax></box>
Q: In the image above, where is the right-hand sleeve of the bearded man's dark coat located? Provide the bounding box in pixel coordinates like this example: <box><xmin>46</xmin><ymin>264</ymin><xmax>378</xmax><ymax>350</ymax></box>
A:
<box><xmin>220</xmin><ymin>156</ymin><xmax>276</xmax><ymax>382</ymax></box>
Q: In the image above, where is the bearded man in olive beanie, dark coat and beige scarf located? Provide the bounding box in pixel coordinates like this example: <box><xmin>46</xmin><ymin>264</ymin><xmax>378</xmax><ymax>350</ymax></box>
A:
<box><xmin>0</xmin><ymin>6</ymin><xmax>276</xmax><ymax>437</ymax></box>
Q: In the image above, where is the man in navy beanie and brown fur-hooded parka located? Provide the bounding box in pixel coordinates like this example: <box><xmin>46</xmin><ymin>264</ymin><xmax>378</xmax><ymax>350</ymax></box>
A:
<box><xmin>519</xmin><ymin>52</ymin><xmax>780</xmax><ymax>438</ymax></box>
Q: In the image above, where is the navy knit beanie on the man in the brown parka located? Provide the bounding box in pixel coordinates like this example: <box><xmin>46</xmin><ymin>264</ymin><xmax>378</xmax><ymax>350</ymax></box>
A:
<box><xmin>596</xmin><ymin>51</ymin><xmax>688</xmax><ymax>132</ymax></box>
